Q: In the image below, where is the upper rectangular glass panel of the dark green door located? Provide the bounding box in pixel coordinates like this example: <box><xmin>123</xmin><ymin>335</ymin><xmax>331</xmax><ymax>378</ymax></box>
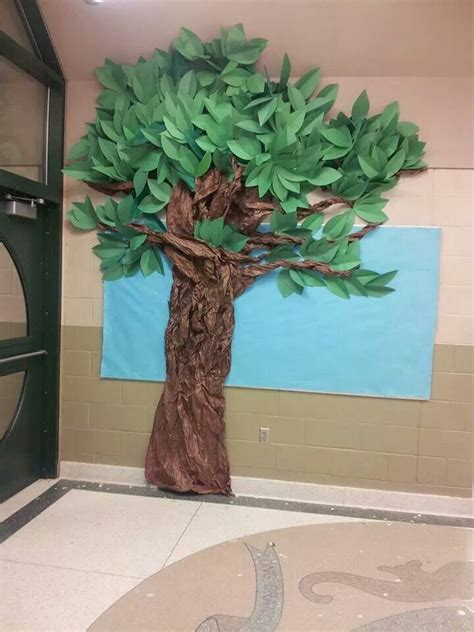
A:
<box><xmin>0</xmin><ymin>57</ymin><xmax>48</xmax><ymax>182</ymax></box>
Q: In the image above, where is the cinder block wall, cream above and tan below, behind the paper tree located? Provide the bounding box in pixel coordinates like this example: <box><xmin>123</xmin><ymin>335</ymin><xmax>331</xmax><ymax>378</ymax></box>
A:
<box><xmin>61</xmin><ymin>77</ymin><xmax>474</xmax><ymax>496</ymax></box>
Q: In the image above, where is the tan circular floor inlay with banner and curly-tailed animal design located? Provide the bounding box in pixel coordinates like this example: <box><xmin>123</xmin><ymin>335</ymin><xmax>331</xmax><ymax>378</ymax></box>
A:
<box><xmin>90</xmin><ymin>522</ymin><xmax>474</xmax><ymax>632</ymax></box>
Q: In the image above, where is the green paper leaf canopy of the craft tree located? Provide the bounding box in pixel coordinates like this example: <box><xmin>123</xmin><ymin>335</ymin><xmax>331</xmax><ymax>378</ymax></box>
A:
<box><xmin>64</xmin><ymin>25</ymin><xmax>425</xmax><ymax>298</ymax></box>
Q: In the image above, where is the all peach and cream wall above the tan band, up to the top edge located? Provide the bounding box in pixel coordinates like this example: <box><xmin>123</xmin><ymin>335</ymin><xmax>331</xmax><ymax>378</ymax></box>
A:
<box><xmin>56</xmin><ymin>0</ymin><xmax>474</xmax><ymax>344</ymax></box>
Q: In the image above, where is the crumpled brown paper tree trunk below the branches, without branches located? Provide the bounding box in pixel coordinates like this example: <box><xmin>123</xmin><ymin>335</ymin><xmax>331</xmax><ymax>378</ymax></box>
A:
<box><xmin>146</xmin><ymin>266</ymin><xmax>234</xmax><ymax>494</ymax></box>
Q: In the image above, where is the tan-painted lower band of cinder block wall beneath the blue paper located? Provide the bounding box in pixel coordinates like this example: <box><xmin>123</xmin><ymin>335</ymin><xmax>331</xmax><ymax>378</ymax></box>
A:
<box><xmin>62</xmin><ymin>326</ymin><xmax>474</xmax><ymax>496</ymax></box>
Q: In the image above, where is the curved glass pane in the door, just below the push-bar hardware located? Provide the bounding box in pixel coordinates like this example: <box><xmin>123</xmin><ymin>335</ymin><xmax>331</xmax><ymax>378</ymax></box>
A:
<box><xmin>0</xmin><ymin>243</ymin><xmax>28</xmax><ymax>340</ymax></box>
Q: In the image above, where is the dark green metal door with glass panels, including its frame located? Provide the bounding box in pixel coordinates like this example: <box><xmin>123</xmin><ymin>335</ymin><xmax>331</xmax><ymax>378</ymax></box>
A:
<box><xmin>0</xmin><ymin>0</ymin><xmax>64</xmax><ymax>502</ymax></box>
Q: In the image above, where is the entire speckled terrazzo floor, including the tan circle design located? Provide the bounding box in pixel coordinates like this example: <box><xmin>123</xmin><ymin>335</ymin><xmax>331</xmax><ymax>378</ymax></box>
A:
<box><xmin>0</xmin><ymin>481</ymin><xmax>474</xmax><ymax>632</ymax></box>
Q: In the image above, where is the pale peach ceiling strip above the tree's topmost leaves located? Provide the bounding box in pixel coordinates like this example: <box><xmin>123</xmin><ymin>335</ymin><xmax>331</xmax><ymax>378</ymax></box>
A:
<box><xmin>39</xmin><ymin>0</ymin><xmax>474</xmax><ymax>80</ymax></box>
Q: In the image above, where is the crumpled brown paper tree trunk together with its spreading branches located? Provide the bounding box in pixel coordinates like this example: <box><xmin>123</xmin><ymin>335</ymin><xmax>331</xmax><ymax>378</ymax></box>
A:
<box><xmin>139</xmin><ymin>166</ymin><xmax>380</xmax><ymax>494</ymax></box>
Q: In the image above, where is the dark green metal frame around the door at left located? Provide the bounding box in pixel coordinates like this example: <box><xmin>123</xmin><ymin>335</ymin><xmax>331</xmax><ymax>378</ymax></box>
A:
<box><xmin>0</xmin><ymin>0</ymin><xmax>65</xmax><ymax>478</ymax></box>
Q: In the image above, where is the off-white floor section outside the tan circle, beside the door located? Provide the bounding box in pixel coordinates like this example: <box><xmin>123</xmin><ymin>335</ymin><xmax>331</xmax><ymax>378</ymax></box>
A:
<box><xmin>0</xmin><ymin>481</ymin><xmax>358</xmax><ymax>632</ymax></box>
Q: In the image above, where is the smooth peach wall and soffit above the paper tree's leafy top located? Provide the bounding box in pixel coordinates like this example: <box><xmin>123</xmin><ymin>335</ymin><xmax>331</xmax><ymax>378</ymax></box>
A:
<box><xmin>41</xmin><ymin>0</ymin><xmax>474</xmax><ymax>168</ymax></box>
